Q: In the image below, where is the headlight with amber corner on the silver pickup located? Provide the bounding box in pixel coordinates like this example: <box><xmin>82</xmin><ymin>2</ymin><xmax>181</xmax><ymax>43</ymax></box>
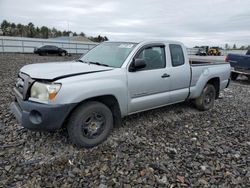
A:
<box><xmin>30</xmin><ymin>82</ymin><xmax>61</xmax><ymax>101</ymax></box>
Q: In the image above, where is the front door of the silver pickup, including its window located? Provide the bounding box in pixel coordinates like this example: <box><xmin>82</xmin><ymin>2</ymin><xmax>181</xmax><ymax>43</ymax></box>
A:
<box><xmin>128</xmin><ymin>45</ymin><xmax>169</xmax><ymax>114</ymax></box>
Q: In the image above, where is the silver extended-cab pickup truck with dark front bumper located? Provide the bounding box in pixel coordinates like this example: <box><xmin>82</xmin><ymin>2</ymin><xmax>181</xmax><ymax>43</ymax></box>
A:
<box><xmin>11</xmin><ymin>41</ymin><xmax>230</xmax><ymax>147</ymax></box>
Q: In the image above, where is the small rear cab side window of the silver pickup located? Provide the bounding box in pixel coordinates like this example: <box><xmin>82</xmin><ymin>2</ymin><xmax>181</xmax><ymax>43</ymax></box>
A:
<box><xmin>169</xmin><ymin>44</ymin><xmax>185</xmax><ymax>67</ymax></box>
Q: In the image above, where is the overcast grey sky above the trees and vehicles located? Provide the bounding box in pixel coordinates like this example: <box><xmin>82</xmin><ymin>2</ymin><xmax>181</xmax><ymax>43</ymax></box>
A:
<box><xmin>0</xmin><ymin>0</ymin><xmax>250</xmax><ymax>47</ymax></box>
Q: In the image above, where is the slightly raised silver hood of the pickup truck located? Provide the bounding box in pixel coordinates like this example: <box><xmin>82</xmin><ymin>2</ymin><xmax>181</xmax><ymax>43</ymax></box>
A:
<box><xmin>20</xmin><ymin>61</ymin><xmax>113</xmax><ymax>81</ymax></box>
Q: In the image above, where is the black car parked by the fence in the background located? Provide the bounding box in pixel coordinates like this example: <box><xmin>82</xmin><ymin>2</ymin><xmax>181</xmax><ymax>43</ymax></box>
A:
<box><xmin>34</xmin><ymin>45</ymin><xmax>68</xmax><ymax>56</ymax></box>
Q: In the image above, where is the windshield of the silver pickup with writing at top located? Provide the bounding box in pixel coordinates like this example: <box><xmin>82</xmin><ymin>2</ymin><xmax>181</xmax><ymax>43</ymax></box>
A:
<box><xmin>80</xmin><ymin>42</ymin><xmax>137</xmax><ymax>68</ymax></box>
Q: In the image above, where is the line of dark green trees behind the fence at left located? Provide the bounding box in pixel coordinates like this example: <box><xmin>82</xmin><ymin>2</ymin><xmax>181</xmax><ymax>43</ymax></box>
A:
<box><xmin>0</xmin><ymin>20</ymin><xmax>108</xmax><ymax>42</ymax></box>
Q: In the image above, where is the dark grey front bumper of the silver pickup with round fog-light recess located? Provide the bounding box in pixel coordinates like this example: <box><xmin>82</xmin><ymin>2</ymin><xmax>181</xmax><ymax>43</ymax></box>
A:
<box><xmin>10</xmin><ymin>91</ymin><xmax>76</xmax><ymax>131</ymax></box>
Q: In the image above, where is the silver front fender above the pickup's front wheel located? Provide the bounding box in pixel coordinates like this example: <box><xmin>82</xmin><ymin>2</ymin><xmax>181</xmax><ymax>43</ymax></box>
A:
<box><xmin>53</xmin><ymin>68</ymin><xmax>127</xmax><ymax>116</ymax></box>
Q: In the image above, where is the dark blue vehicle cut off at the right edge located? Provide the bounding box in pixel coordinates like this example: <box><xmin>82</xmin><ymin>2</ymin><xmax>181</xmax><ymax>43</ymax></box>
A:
<box><xmin>226</xmin><ymin>49</ymin><xmax>250</xmax><ymax>80</ymax></box>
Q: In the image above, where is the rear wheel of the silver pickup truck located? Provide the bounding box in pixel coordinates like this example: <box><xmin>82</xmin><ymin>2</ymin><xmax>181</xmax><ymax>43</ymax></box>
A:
<box><xmin>195</xmin><ymin>84</ymin><xmax>216</xmax><ymax>111</ymax></box>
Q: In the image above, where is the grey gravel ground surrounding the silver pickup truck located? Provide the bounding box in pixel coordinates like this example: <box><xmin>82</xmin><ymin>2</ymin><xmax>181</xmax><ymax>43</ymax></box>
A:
<box><xmin>0</xmin><ymin>54</ymin><xmax>250</xmax><ymax>188</ymax></box>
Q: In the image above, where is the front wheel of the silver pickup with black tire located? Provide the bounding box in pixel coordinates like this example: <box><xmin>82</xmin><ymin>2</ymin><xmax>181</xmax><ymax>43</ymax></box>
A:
<box><xmin>67</xmin><ymin>101</ymin><xmax>113</xmax><ymax>148</ymax></box>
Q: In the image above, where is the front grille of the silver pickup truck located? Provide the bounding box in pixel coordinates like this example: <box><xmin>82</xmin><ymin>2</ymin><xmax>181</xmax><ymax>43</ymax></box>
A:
<box><xmin>16</xmin><ymin>72</ymin><xmax>34</xmax><ymax>99</ymax></box>
